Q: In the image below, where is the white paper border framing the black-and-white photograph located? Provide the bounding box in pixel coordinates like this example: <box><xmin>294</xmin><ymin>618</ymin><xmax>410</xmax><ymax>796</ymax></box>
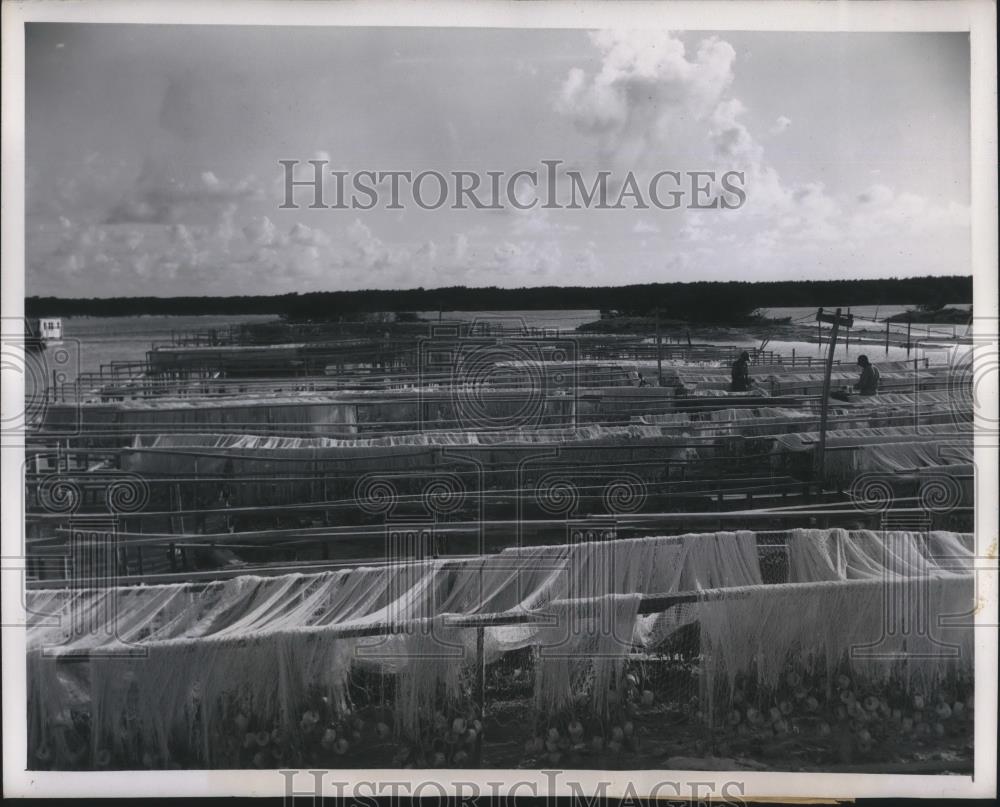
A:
<box><xmin>0</xmin><ymin>0</ymin><xmax>998</xmax><ymax>800</ymax></box>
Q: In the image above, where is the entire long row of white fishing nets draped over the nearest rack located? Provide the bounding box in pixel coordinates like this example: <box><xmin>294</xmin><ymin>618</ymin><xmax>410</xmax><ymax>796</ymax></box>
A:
<box><xmin>28</xmin><ymin>530</ymin><xmax>972</xmax><ymax>766</ymax></box>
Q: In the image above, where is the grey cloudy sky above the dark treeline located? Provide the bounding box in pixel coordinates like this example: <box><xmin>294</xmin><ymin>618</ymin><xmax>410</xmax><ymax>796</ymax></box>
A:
<box><xmin>26</xmin><ymin>23</ymin><xmax>971</xmax><ymax>297</ymax></box>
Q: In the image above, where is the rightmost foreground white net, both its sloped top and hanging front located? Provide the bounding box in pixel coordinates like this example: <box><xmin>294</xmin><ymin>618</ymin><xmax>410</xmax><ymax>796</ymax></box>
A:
<box><xmin>693</xmin><ymin>529</ymin><xmax>974</xmax><ymax>712</ymax></box>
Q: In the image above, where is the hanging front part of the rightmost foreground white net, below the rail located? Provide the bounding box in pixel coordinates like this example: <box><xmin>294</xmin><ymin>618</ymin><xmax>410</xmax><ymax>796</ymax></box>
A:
<box><xmin>694</xmin><ymin>576</ymin><xmax>973</xmax><ymax>704</ymax></box>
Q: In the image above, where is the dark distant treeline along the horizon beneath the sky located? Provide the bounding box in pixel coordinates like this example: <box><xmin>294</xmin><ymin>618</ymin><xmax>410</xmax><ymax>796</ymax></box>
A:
<box><xmin>25</xmin><ymin>276</ymin><xmax>972</xmax><ymax>322</ymax></box>
